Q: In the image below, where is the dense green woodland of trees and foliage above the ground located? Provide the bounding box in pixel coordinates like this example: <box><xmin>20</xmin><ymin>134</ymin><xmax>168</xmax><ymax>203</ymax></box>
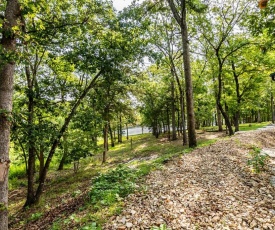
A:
<box><xmin>0</xmin><ymin>0</ymin><xmax>275</xmax><ymax>230</ymax></box>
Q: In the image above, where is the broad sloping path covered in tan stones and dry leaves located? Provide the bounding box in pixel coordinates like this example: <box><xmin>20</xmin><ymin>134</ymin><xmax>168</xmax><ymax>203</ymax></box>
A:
<box><xmin>103</xmin><ymin>129</ymin><xmax>275</xmax><ymax>230</ymax></box>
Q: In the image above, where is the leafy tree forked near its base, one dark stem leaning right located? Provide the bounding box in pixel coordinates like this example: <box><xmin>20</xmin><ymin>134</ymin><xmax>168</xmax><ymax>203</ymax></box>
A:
<box><xmin>9</xmin><ymin>0</ymin><xmax>149</xmax><ymax>207</ymax></box>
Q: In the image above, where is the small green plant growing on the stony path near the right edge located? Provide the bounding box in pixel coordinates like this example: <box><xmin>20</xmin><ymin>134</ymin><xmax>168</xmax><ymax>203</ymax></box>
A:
<box><xmin>247</xmin><ymin>147</ymin><xmax>268</xmax><ymax>173</ymax></box>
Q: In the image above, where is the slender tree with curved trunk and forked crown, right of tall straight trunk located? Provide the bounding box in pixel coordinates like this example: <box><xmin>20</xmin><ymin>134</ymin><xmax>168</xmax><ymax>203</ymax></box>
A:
<box><xmin>196</xmin><ymin>1</ymin><xmax>250</xmax><ymax>135</ymax></box>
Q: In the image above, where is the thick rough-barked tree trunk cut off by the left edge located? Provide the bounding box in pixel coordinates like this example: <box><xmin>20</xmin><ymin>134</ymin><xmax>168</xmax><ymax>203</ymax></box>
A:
<box><xmin>0</xmin><ymin>0</ymin><xmax>20</xmax><ymax>230</ymax></box>
